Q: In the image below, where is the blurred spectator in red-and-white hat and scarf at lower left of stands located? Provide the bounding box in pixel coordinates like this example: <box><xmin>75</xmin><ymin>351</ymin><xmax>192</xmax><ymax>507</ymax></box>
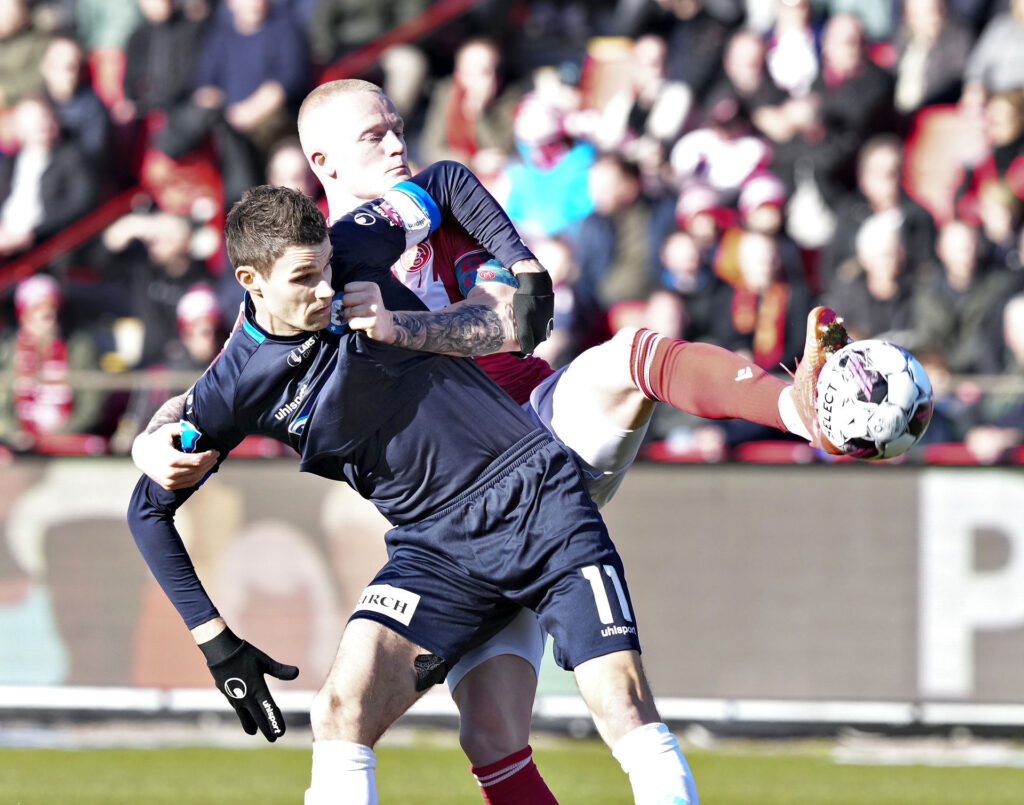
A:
<box><xmin>0</xmin><ymin>274</ymin><xmax>103</xmax><ymax>450</ymax></box>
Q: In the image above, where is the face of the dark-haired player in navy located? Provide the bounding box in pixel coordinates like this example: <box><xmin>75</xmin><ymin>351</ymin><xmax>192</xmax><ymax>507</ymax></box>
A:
<box><xmin>245</xmin><ymin>238</ymin><xmax>334</xmax><ymax>336</ymax></box>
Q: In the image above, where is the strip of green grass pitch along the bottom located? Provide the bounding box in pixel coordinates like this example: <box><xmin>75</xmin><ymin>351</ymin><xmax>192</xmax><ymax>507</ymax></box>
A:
<box><xmin>0</xmin><ymin>740</ymin><xmax>1024</xmax><ymax>805</ymax></box>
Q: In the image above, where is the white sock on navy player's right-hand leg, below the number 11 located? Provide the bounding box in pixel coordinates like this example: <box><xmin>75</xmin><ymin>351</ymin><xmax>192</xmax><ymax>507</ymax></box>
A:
<box><xmin>611</xmin><ymin>724</ymin><xmax>698</xmax><ymax>805</ymax></box>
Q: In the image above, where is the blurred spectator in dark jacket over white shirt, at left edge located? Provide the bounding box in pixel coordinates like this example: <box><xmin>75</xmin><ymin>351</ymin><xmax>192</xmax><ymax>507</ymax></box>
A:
<box><xmin>0</xmin><ymin>95</ymin><xmax>99</xmax><ymax>256</ymax></box>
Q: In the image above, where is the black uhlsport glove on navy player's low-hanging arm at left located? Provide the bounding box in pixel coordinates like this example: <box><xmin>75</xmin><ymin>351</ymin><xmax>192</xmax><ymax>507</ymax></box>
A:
<box><xmin>199</xmin><ymin>629</ymin><xmax>299</xmax><ymax>743</ymax></box>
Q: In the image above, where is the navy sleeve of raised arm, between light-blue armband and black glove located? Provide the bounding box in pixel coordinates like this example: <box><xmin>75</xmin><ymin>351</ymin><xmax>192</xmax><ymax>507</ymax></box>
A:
<box><xmin>399</xmin><ymin>162</ymin><xmax>534</xmax><ymax>266</ymax></box>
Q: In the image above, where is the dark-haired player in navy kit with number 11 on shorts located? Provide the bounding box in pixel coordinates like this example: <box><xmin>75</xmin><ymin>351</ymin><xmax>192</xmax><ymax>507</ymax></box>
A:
<box><xmin>129</xmin><ymin>174</ymin><xmax>696</xmax><ymax>805</ymax></box>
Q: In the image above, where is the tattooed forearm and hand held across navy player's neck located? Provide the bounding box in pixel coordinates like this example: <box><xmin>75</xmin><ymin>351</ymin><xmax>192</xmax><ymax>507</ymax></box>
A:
<box><xmin>342</xmin><ymin>282</ymin><xmax>519</xmax><ymax>355</ymax></box>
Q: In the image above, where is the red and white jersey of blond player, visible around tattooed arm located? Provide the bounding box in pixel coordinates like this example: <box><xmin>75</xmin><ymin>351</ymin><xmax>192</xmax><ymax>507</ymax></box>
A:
<box><xmin>391</xmin><ymin>222</ymin><xmax>554</xmax><ymax>404</ymax></box>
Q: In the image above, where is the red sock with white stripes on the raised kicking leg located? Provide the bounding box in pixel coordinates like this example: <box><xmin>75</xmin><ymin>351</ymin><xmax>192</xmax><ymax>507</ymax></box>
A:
<box><xmin>630</xmin><ymin>330</ymin><xmax>786</xmax><ymax>430</ymax></box>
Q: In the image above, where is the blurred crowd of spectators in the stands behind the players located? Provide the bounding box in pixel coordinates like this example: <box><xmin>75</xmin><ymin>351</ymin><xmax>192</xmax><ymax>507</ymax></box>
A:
<box><xmin>0</xmin><ymin>0</ymin><xmax>1024</xmax><ymax>463</ymax></box>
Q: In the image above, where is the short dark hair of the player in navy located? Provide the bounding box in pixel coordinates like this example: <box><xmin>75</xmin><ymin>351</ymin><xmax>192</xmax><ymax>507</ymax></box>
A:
<box><xmin>224</xmin><ymin>184</ymin><xmax>327</xmax><ymax>277</ymax></box>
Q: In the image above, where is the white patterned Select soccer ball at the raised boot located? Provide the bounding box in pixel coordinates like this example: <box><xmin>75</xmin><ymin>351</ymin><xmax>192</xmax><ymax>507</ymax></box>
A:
<box><xmin>816</xmin><ymin>340</ymin><xmax>935</xmax><ymax>461</ymax></box>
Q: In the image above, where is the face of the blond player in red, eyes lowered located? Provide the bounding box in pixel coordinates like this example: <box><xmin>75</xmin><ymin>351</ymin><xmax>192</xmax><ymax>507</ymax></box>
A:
<box><xmin>314</xmin><ymin>92</ymin><xmax>411</xmax><ymax>201</ymax></box>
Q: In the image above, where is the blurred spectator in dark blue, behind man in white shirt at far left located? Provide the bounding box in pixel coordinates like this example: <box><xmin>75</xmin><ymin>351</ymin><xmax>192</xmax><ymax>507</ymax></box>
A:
<box><xmin>39</xmin><ymin>36</ymin><xmax>111</xmax><ymax>171</ymax></box>
